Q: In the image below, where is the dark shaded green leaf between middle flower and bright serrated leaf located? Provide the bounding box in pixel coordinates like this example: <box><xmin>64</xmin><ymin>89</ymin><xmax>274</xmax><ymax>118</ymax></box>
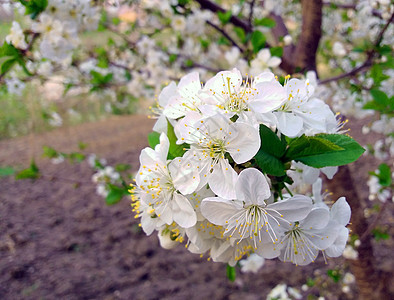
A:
<box><xmin>255</xmin><ymin>125</ymin><xmax>286</xmax><ymax>176</ymax></box>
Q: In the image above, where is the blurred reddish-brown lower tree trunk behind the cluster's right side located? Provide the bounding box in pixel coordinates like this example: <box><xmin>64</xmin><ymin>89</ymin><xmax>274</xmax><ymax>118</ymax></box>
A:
<box><xmin>327</xmin><ymin>166</ymin><xmax>387</xmax><ymax>300</ymax></box>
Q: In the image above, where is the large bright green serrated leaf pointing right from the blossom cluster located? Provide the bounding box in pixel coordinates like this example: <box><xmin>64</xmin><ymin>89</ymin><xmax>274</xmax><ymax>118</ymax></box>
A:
<box><xmin>285</xmin><ymin>134</ymin><xmax>365</xmax><ymax>168</ymax></box>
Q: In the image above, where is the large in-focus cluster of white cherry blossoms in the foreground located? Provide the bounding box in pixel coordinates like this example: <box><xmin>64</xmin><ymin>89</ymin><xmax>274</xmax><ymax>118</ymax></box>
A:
<box><xmin>131</xmin><ymin>69</ymin><xmax>350</xmax><ymax>266</ymax></box>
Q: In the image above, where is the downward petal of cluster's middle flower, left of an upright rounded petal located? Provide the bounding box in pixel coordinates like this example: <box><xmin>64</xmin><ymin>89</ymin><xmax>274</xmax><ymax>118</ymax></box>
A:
<box><xmin>208</xmin><ymin>159</ymin><xmax>238</xmax><ymax>199</ymax></box>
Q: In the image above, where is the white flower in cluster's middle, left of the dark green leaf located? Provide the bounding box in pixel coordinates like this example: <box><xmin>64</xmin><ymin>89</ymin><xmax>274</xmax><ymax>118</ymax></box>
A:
<box><xmin>178</xmin><ymin>114</ymin><xmax>260</xmax><ymax>199</ymax></box>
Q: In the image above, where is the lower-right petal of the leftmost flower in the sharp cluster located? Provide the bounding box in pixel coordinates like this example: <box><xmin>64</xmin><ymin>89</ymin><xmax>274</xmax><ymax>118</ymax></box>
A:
<box><xmin>172</xmin><ymin>193</ymin><xmax>197</xmax><ymax>228</ymax></box>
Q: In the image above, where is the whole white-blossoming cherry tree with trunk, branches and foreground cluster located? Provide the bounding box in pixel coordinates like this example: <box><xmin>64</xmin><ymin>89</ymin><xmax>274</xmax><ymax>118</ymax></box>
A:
<box><xmin>0</xmin><ymin>0</ymin><xmax>394</xmax><ymax>299</ymax></box>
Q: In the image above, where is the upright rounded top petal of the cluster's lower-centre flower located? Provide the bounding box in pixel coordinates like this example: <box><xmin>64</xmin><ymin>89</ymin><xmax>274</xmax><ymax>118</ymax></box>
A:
<box><xmin>235</xmin><ymin>168</ymin><xmax>271</xmax><ymax>206</ymax></box>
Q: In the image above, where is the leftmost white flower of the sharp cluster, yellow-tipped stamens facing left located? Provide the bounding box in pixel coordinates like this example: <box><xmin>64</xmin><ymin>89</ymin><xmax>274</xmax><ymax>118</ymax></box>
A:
<box><xmin>136</xmin><ymin>133</ymin><xmax>199</xmax><ymax>228</ymax></box>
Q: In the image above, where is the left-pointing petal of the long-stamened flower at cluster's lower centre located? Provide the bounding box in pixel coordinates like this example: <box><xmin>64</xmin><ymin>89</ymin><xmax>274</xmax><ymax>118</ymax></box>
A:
<box><xmin>201</xmin><ymin>197</ymin><xmax>242</xmax><ymax>225</ymax></box>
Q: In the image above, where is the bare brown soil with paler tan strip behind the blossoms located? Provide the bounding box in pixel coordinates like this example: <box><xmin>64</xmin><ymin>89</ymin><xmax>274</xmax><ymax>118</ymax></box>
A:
<box><xmin>0</xmin><ymin>116</ymin><xmax>393</xmax><ymax>300</ymax></box>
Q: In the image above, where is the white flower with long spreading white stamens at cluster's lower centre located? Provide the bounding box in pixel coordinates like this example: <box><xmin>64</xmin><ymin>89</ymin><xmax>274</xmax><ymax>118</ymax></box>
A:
<box><xmin>201</xmin><ymin>168</ymin><xmax>312</xmax><ymax>258</ymax></box>
